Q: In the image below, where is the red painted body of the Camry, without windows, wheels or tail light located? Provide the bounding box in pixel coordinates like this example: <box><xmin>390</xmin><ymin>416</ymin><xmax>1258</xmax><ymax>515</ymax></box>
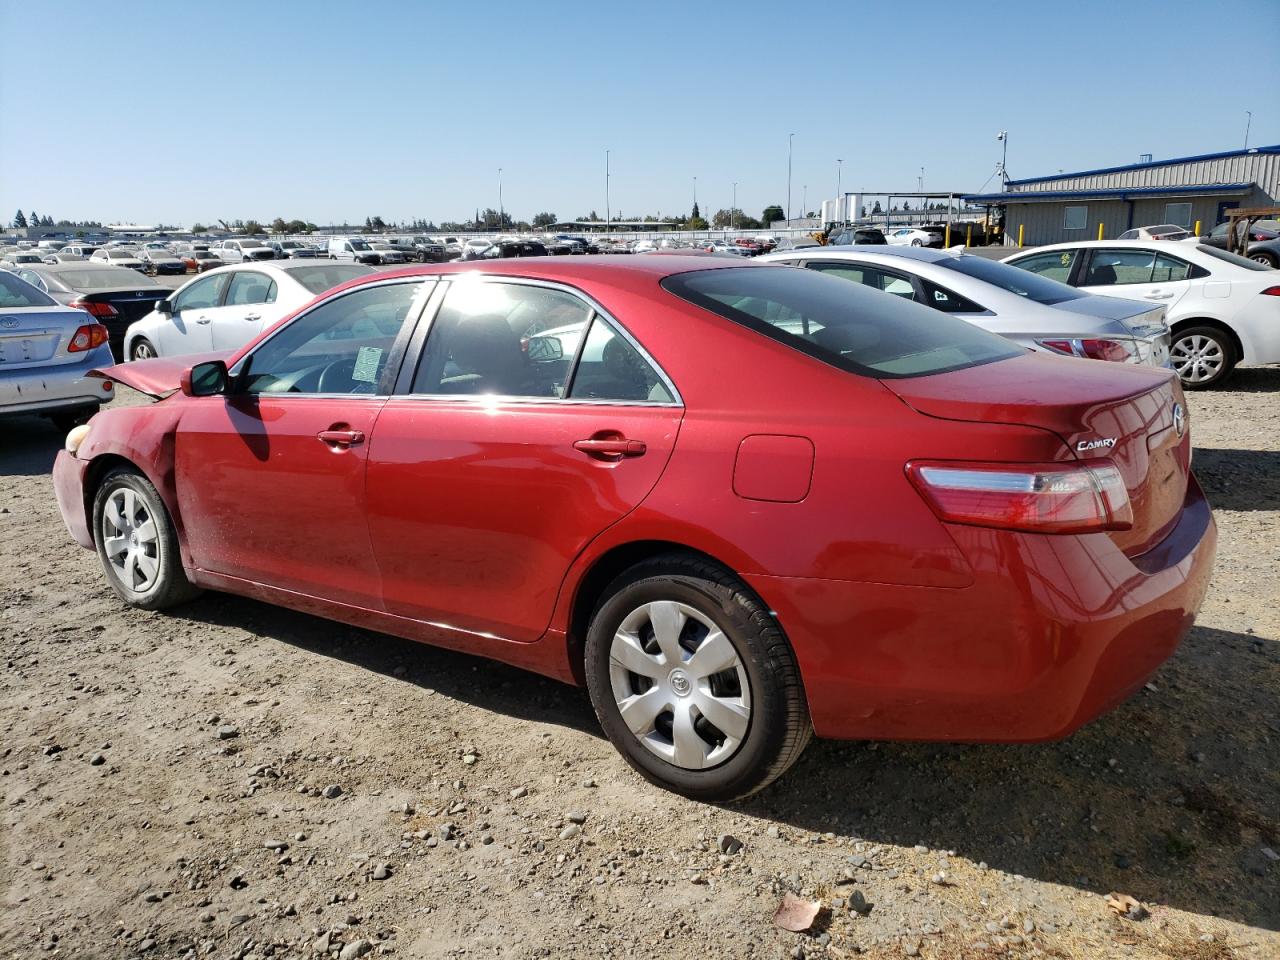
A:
<box><xmin>55</xmin><ymin>256</ymin><xmax>1216</xmax><ymax>741</ymax></box>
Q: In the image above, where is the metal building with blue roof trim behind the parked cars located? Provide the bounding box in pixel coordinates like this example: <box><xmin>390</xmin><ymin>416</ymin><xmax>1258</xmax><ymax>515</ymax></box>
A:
<box><xmin>963</xmin><ymin>145</ymin><xmax>1280</xmax><ymax>246</ymax></box>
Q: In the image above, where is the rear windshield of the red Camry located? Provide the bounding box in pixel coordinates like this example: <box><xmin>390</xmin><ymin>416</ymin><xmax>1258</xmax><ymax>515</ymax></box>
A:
<box><xmin>662</xmin><ymin>266</ymin><xmax>1024</xmax><ymax>379</ymax></box>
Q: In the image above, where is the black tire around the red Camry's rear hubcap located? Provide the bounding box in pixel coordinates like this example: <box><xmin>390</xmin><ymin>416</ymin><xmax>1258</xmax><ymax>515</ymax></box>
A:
<box><xmin>585</xmin><ymin>553</ymin><xmax>813</xmax><ymax>803</ymax></box>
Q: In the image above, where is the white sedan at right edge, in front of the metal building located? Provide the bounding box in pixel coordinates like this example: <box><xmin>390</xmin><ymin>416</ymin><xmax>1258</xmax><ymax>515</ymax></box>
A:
<box><xmin>1005</xmin><ymin>241</ymin><xmax>1280</xmax><ymax>390</ymax></box>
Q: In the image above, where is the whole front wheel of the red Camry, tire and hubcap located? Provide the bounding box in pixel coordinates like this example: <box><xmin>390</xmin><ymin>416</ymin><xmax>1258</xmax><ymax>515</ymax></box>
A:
<box><xmin>93</xmin><ymin>467</ymin><xmax>200</xmax><ymax>611</ymax></box>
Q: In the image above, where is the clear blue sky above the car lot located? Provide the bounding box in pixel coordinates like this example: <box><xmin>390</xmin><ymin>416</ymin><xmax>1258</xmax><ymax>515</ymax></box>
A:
<box><xmin>0</xmin><ymin>0</ymin><xmax>1280</xmax><ymax>224</ymax></box>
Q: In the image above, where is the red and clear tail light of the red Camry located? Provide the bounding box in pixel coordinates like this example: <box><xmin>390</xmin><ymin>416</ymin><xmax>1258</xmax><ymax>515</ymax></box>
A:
<box><xmin>906</xmin><ymin>461</ymin><xmax>1133</xmax><ymax>534</ymax></box>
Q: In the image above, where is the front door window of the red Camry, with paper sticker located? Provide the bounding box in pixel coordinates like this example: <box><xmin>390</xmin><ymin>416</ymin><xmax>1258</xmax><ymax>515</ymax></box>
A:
<box><xmin>239</xmin><ymin>280</ymin><xmax>433</xmax><ymax>394</ymax></box>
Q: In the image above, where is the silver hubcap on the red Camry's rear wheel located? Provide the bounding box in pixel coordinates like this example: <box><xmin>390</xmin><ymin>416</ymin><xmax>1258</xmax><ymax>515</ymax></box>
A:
<box><xmin>609</xmin><ymin>600</ymin><xmax>751</xmax><ymax>771</ymax></box>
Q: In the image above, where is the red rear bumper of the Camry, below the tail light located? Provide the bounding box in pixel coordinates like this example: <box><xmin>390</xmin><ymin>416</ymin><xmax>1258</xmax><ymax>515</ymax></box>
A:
<box><xmin>746</xmin><ymin>477</ymin><xmax>1217</xmax><ymax>742</ymax></box>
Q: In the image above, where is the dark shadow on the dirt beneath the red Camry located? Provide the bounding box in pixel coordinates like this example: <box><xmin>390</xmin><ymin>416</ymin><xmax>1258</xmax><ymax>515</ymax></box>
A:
<box><xmin>178</xmin><ymin>594</ymin><xmax>1280</xmax><ymax>929</ymax></box>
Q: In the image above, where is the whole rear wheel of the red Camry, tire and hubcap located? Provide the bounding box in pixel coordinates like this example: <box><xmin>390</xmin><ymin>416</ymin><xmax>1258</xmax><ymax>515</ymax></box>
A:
<box><xmin>585</xmin><ymin>554</ymin><xmax>813</xmax><ymax>801</ymax></box>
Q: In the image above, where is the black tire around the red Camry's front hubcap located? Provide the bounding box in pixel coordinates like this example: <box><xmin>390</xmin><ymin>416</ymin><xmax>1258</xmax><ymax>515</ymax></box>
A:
<box><xmin>93</xmin><ymin>467</ymin><xmax>201</xmax><ymax>611</ymax></box>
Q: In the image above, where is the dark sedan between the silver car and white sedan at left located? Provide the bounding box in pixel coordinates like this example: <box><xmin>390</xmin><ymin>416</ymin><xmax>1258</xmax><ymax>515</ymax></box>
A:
<box><xmin>17</xmin><ymin>260</ymin><xmax>169</xmax><ymax>360</ymax></box>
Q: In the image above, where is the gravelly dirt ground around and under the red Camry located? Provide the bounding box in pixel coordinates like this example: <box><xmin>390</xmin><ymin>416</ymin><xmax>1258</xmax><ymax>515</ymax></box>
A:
<box><xmin>0</xmin><ymin>369</ymin><xmax>1280</xmax><ymax>960</ymax></box>
